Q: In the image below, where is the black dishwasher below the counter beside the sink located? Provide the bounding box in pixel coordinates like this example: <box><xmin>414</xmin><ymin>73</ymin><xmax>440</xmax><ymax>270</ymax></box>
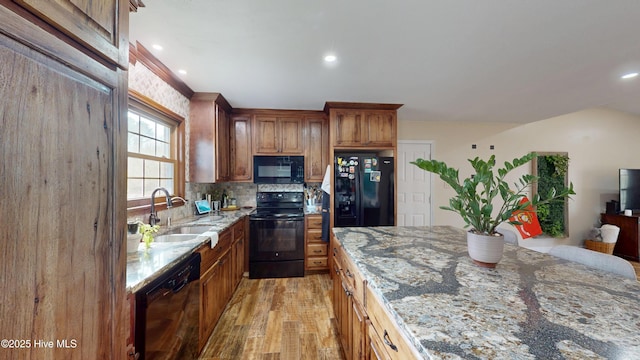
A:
<box><xmin>135</xmin><ymin>253</ymin><xmax>200</xmax><ymax>360</ymax></box>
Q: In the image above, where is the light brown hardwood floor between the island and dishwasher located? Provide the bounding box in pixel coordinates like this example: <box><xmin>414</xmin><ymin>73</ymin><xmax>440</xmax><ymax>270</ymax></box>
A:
<box><xmin>200</xmin><ymin>274</ymin><xmax>343</xmax><ymax>360</ymax></box>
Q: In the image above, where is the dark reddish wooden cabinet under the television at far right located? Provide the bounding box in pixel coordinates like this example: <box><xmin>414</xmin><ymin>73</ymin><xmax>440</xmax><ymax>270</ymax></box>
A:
<box><xmin>600</xmin><ymin>214</ymin><xmax>640</xmax><ymax>261</ymax></box>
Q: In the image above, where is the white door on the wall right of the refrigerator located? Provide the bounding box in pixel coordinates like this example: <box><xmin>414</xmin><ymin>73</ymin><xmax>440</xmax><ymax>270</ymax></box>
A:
<box><xmin>397</xmin><ymin>140</ymin><xmax>431</xmax><ymax>226</ymax></box>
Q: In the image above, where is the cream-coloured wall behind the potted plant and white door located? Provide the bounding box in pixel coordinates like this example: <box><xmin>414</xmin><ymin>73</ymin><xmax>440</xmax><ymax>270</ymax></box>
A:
<box><xmin>398</xmin><ymin>108</ymin><xmax>640</xmax><ymax>245</ymax></box>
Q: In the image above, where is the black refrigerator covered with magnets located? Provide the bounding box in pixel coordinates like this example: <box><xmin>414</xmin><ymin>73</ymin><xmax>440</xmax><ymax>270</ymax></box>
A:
<box><xmin>333</xmin><ymin>153</ymin><xmax>395</xmax><ymax>227</ymax></box>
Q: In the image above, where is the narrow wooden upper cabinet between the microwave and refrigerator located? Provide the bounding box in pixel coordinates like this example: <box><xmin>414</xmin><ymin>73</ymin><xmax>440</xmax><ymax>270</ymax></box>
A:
<box><xmin>304</xmin><ymin>117</ymin><xmax>330</xmax><ymax>182</ymax></box>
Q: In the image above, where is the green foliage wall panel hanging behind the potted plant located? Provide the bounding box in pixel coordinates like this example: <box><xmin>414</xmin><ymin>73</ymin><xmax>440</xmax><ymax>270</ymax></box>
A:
<box><xmin>537</xmin><ymin>154</ymin><xmax>569</xmax><ymax>237</ymax></box>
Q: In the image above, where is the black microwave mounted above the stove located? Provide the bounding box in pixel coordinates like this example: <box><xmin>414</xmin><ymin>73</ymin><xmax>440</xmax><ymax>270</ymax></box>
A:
<box><xmin>253</xmin><ymin>155</ymin><xmax>304</xmax><ymax>184</ymax></box>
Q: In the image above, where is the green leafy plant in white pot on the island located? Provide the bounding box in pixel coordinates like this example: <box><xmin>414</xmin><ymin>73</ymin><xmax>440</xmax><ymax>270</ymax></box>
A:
<box><xmin>411</xmin><ymin>152</ymin><xmax>575</xmax><ymax>267</ymax></box>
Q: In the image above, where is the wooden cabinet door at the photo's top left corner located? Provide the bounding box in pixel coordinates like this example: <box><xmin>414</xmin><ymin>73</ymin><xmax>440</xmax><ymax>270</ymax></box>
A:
<box><xmin>14</xmin><ymin>0</ymin><xmax>129</xmax><ymax>69</ymax></box>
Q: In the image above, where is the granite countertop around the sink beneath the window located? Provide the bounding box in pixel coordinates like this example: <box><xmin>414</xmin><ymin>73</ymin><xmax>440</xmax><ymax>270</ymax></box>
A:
<box><xmin>126</xmin><ymin>208</ymin><xmax>253</xmax><ymax>293</ymax></box>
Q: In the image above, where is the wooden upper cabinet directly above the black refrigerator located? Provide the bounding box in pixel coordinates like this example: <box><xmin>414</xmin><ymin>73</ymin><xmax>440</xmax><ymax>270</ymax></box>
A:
<box><xmin>325</xmin><ymin>102</ymin><xmax>402</xmax><ymax>149</ymax></box>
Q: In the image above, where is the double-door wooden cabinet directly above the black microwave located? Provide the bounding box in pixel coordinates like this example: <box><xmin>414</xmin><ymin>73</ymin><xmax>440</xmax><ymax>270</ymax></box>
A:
<box><xmin>253</xmin><ymin>115</ymin><xmax>304</xmax><ymax>155</ymax></box>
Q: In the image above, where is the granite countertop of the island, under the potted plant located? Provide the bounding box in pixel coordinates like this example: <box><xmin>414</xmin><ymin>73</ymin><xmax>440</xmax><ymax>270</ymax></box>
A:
<box><xmin>333</xmin><ymin>226</ymin><xmax>640</xmax><ymax>359</ymax></box>
